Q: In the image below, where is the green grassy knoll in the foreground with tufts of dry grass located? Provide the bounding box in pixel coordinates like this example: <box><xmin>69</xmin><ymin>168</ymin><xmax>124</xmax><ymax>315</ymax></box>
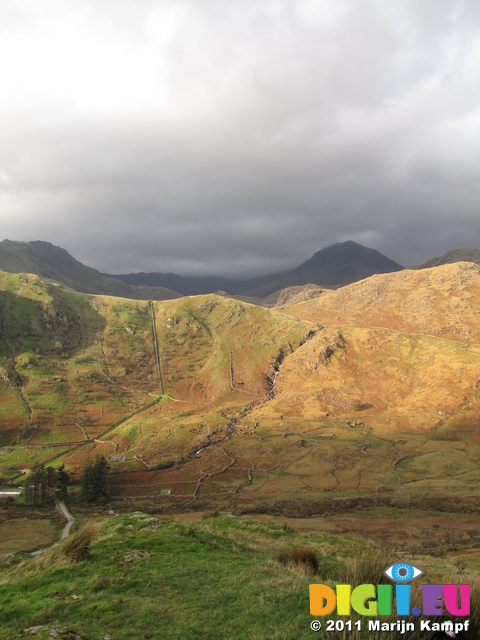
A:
<box><xmin>0</xmin><ymin>512</ymin><xmax>474</xmax><ymax>640</ymax></box>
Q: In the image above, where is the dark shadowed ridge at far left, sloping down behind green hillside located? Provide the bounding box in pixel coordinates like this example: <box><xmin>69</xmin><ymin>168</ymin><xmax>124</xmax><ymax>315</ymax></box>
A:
<box><xmin>0</xmin><ymin>240</ymin><xmax>178</xmax><ymax>300</ymax></box>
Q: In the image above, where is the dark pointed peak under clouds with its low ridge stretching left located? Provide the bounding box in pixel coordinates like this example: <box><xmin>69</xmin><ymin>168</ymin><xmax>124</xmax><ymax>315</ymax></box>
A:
<box><xmin>109</xmin><ymin>240</ymin><xmax>403</xmax><ymax>298</ymax></box>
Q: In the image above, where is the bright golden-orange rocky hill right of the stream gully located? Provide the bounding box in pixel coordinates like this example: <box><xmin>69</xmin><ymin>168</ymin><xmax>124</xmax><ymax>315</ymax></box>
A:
<box><xmin>268</xmin><ymin>262</ymin><xmax>480</xmax><ymax>432</ymax></box>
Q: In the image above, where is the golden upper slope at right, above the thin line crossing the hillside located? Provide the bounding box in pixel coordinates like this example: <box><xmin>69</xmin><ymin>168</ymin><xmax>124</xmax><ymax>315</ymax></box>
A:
<box><xmin>282</xmin><ymin>262</ymin><xmax>480</xmax><ymax>342</ymax></box>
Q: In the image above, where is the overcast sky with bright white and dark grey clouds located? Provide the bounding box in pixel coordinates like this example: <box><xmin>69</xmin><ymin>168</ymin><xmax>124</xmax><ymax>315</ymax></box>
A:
<box><xmin>0</xmin><ymin>0</ymin><xmax>480</xmax><ymax>277</ymax></box>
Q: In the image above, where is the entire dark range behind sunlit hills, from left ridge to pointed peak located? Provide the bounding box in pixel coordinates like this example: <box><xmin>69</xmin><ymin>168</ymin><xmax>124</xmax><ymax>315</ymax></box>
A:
<box><xmin>0</xmin><ymin>240</ymin><xmax>403</xmax><ymax>304</ymax></box>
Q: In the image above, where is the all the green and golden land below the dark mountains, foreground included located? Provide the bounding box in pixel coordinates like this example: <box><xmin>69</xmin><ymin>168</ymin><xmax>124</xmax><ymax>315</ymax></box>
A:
<box><xmin>0</xmin><ymin>263</ymin><xmax>480</xmax><ymax>640</ymax></box>
